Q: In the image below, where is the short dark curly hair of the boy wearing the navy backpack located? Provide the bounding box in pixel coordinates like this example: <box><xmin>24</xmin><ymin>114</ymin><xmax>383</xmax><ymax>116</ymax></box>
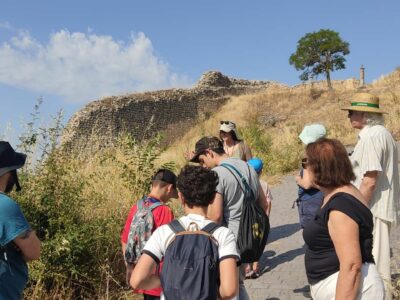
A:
<box><xmin>177</xmin><ymin>165</ymin><xmax>218</xmax><ymax>208</ymax></box>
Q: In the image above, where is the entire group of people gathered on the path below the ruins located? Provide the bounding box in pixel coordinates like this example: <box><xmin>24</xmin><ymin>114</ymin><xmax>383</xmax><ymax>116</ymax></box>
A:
<box><xmin>0</xmin><ymin>93</ymin><xmax>400</xmax><ymax>300</ymax></box>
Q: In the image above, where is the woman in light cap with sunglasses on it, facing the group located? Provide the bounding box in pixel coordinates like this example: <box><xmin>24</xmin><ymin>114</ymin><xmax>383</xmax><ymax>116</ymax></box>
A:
<box><xmin>219</xmin><ymin>121</ymin><xmax>253</xmax><ymax>161</ymax></box>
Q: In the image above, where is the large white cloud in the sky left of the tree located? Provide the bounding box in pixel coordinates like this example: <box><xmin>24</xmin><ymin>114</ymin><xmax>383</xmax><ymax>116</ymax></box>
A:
<box><xmin>0</xmin><ymin>29</ymin><xmax>191</xmax><ymax>102</ymax></box>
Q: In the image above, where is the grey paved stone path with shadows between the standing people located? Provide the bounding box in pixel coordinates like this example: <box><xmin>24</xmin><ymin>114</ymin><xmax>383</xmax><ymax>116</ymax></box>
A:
<box><xmin>245</xmin><ymin>176</ymin><xmax>400</xmax><ymax>300</ymax></box>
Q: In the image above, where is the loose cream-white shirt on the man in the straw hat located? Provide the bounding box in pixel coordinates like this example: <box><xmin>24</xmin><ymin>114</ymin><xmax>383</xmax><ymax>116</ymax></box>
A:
<box><xmin>350</xmin><ymin>125</ymin><xmax>400</xmax><ymax>223</ymax></box>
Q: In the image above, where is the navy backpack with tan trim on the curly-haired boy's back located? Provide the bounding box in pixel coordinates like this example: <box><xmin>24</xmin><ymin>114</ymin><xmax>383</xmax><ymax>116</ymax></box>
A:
<box><xmin>160</xmin><ymin>220</ymin><xmax>220</xmax><ymax>300</ymax></box>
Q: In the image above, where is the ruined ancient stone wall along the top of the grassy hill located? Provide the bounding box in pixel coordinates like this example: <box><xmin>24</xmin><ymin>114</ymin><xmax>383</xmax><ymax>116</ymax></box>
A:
<box><xmin>61</xmin><ymin>71</ymin><xmax>281</xmax><ymax>153</ymax></box>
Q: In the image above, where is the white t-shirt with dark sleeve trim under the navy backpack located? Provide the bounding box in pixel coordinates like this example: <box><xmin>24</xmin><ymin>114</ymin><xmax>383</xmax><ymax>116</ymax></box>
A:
<box><xmin>143</xmin><ymin>214</ymin><xmax>240</xmax><ymax>262</ymax></box>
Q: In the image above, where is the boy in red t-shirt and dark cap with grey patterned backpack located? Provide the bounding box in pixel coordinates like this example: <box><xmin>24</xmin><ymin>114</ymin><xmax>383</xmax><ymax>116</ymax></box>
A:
<box><xmin>121</xmin><ymin>169</ymin><xmax>177</xmax><ymax>300</ymax></box>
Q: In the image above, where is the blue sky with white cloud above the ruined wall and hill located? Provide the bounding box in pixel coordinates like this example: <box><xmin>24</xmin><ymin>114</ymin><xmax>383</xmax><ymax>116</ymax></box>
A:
<box><xmin>0</xmin><ymin>0</ymin><xmax>400</xmax><ymax>145</ymax></box>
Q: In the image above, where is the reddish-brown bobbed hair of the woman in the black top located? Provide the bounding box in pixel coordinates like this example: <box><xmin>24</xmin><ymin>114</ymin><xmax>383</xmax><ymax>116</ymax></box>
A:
<box><xmin>306</xmin><ymin>138</ymin><xmax>356</xmax><ymax>188</ymax></box>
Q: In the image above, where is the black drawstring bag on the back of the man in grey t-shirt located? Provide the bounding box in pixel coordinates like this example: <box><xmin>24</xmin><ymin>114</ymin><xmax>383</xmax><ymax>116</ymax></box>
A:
<box><xmin>220</xmin><ymin>163</ymin><xmax>270</xmax><ymax>263</ymax></box>
